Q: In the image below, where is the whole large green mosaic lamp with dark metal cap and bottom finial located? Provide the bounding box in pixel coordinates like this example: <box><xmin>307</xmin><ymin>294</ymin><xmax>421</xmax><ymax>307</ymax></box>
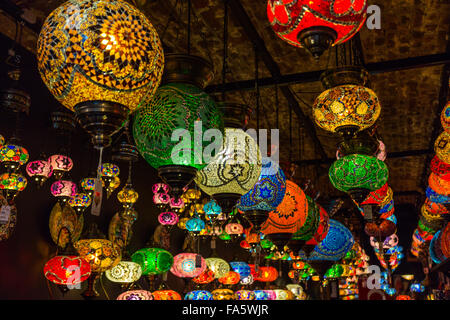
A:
<box><xmin>133</xmin><ymin>54</ymin><xmax>223</xmax><ymax>196</ymax></box>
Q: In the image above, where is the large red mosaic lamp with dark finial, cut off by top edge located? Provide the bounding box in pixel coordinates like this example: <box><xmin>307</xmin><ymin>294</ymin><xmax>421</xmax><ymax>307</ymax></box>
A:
<box><xmin>267</xmin><ymin>0</ymin><xmax>367</xmax><ymax>59</ymax></box>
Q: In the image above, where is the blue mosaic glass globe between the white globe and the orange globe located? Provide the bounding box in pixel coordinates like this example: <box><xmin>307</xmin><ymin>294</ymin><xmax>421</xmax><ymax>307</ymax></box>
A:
<box><xmin>237</xmin><ymin>157</ymin><xmax>286</xmax><ymax>212</ymax></box>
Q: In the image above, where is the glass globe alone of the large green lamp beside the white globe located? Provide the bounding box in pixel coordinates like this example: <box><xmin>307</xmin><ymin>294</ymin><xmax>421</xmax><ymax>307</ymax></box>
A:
<box><xmin>133</xmin><ymin>83</ymin><xmax>223</xmax><ymax>169</ymax></box>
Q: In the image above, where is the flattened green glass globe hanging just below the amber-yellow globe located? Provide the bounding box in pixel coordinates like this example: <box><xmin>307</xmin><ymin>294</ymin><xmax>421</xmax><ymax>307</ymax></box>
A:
<box><xmin>328</xmin><ymin>154</ymin><xmax>389</xmax><ymax>192</ymax></box>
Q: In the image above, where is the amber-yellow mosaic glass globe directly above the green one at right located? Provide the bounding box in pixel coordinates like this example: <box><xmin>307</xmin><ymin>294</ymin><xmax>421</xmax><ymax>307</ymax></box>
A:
<box><xmin>313</xmin><ymin>85</ymin><xmax>381</xmax><ymax>132</ymax></box>
